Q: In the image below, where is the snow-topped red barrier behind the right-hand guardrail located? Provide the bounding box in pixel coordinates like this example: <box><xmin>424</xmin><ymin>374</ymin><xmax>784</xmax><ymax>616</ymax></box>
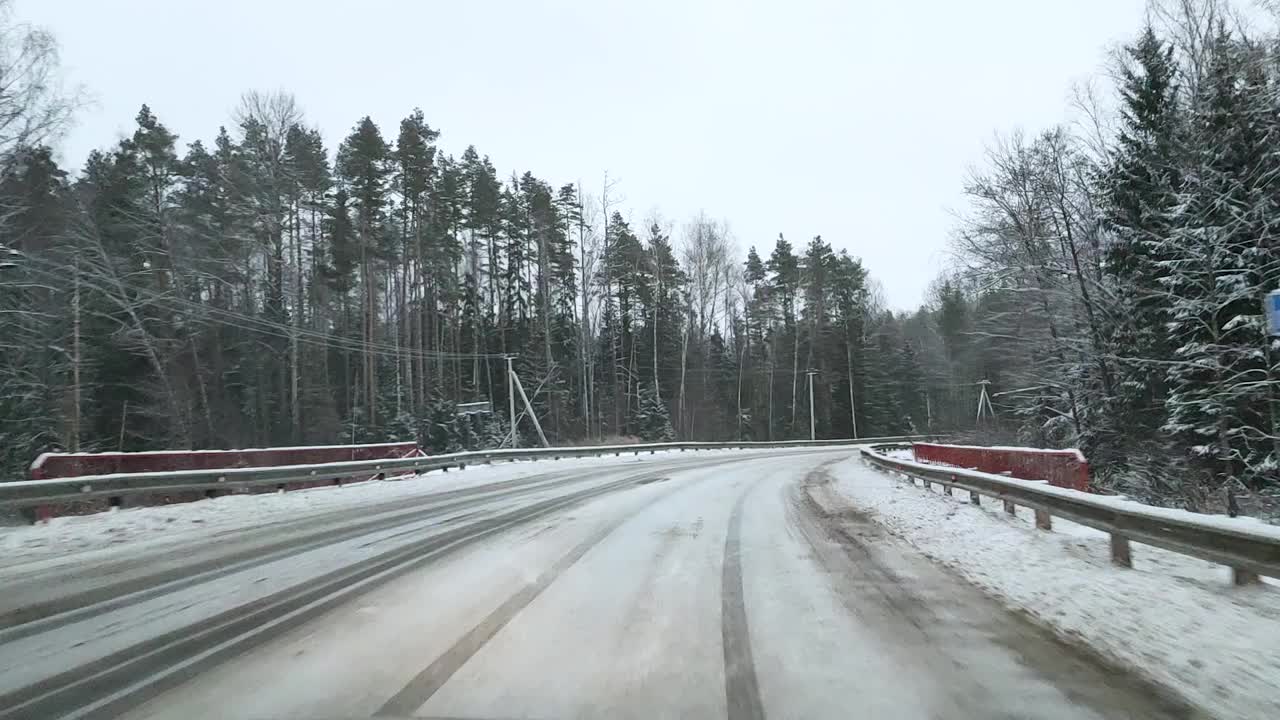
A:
<box><xmin>911</xmin><ymin>442</ymin><xmax>1089</xmax><ymax>492</ymax></box>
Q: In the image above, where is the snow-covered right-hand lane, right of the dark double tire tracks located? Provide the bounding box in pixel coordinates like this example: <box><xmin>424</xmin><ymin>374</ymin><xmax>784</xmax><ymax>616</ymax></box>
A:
<box><xmin>125</xmin><ymin>451</ymin><xmax>1170</xmax><ymax>720</ymax></box>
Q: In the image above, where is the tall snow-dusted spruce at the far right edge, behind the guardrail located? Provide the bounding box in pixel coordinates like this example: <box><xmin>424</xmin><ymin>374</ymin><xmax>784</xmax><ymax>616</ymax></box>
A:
<box><xmin>1155</xmin><ymin>31</ymin><xmax>1280</xmax><ymax>509</ymax></box>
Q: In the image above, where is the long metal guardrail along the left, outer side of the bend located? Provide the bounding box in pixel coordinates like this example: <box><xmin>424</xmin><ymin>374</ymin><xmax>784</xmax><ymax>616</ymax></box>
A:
<box><xmin>0</xmin><ymin>436</ymin><xmax>920</xmax><ymax>507</ymax></box>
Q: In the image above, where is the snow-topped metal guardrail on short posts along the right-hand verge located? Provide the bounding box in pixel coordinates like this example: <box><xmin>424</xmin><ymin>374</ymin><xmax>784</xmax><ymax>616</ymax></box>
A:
<box><xmin>861</xmin><ymin>446</ymin><xmax>1280</xmax><ymax>584</ymax></box>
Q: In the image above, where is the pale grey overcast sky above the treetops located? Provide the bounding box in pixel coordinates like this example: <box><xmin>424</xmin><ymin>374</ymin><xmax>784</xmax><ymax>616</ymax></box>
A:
<box><xmin>15</xmin><ymin>0</ymin><xmax>1143</xmax><ymax>309</ymax></box>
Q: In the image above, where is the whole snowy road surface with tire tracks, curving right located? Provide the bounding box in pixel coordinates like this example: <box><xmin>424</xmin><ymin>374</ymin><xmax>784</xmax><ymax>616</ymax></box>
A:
<box><xmin>0</xmin><ymin>450</ymin><xmax>1185</xmax><ymax>720</ymax></box>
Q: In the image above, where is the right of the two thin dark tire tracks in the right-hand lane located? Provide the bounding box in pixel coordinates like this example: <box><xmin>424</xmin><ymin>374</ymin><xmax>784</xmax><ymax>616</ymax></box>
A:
<box><xmin>721</xmin><ymin>488</ymin><xmax>764</xmax><ymax>720</ymax></box>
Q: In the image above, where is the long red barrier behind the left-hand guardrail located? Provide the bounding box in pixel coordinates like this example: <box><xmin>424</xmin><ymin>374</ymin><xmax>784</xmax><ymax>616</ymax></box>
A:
<box><xmin>31</xmin><ymin>442</ymin><xmax>417</xmax><ymax>480</ymax></box>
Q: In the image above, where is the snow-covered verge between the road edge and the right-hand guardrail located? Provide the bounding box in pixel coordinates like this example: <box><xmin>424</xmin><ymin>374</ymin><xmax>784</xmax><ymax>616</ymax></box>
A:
<box><xmin>831</xmin><ymin>459</ymin><xmax>1280</xmax><ymax>719</ymax></box>
